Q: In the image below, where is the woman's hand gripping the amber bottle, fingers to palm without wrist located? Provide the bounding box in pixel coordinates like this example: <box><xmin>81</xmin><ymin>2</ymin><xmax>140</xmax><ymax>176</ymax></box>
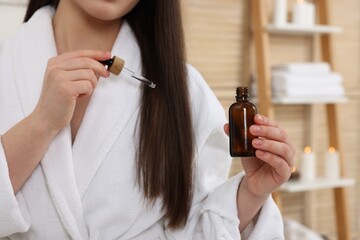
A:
<box><xmin>224</xmin><ymin>114</ymin><xmax>295</xmax><ymax>197</ymax></box>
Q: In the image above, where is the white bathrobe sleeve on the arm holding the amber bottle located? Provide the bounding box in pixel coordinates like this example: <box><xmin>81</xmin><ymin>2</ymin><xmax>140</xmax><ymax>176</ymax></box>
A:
<box><xmin>165</xmin><ymin>66</ymin><xmax>284</xmax><ymax>240</ymax></box>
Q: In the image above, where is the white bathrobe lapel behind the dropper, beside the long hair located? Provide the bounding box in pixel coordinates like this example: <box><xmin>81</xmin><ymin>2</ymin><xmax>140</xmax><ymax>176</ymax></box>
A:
<box><xmin>73</xmin><ymin>22</ymin><xmax>141</xmax><ymax>196</ymax></box>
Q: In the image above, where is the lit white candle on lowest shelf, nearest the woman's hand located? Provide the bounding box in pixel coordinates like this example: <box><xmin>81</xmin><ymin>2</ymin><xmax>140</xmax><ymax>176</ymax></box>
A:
<box><xmin>300</xmin><ymin>147</ymin><xmax>316</xmax><ymax>181</ymax></box>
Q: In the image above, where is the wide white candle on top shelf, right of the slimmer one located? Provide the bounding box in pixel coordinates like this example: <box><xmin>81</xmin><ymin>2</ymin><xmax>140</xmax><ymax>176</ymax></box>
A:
<box><xmin>292</xmin><ymin>0</ymin><xmax>315</xmax><ymax>26</ymax></box>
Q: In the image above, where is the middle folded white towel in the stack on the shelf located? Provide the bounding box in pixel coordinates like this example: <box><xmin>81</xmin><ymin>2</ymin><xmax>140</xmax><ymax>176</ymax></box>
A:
<box><xmin>271</xmin><ymin>71</ymin><xmax>343</xmax><ymax>87</ymax></box>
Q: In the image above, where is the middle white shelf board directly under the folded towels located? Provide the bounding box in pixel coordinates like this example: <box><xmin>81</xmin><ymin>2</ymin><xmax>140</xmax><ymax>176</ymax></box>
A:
<box><xmin>252</xmin><ymin>96</ymin><xmax>348</xmax><ymax>105</ymax></box>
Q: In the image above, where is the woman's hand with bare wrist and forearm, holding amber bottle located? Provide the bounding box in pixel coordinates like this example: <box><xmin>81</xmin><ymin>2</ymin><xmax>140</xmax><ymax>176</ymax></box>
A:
<box><xmin>224</xmin><ymin>114</ymin><xmax>295</xmax><ymax>231</ymax></box>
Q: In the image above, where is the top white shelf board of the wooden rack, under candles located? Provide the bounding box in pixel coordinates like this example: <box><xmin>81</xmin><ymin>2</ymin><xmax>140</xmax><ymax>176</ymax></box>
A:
<box><xmin>267</xmin><ymin>24</ymin><xmax>342</xmax><ymax>35</ymax></box>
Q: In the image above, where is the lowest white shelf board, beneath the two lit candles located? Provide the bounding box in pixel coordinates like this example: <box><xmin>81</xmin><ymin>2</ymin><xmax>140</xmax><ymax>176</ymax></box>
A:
<box><xmin>280</xmin><ymin>178</ymin><xmax>355</xmax><ymax>193</ymax></box>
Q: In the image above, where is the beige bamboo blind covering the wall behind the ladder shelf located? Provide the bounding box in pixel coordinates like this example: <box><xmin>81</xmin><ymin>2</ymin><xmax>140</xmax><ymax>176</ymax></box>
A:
<box><xmin>183</xmin><ymin>0</ymin><xmax>360</xmax><ymax>239</ymax></box>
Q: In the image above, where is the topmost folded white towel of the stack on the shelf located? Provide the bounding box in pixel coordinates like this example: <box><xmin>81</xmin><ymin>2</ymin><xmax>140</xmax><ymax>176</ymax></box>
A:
<box><xmin>272</xmin><ymin>62</ymin><xmax>331</xmax><ymax>74</ymax></box>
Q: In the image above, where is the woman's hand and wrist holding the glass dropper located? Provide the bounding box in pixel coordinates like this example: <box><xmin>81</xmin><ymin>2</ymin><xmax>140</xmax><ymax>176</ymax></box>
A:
<box><xmin>33</xmin><ymin>50</ymin><xmax>111</xmax><ymax>132</ymax></box>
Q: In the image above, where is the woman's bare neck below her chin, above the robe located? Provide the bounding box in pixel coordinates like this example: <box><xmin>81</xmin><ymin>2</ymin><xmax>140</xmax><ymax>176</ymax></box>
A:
<box><xmin>53</xmin><ymin>1</ymin><xmax>121</xmax><ymax>54</ymax></box>
